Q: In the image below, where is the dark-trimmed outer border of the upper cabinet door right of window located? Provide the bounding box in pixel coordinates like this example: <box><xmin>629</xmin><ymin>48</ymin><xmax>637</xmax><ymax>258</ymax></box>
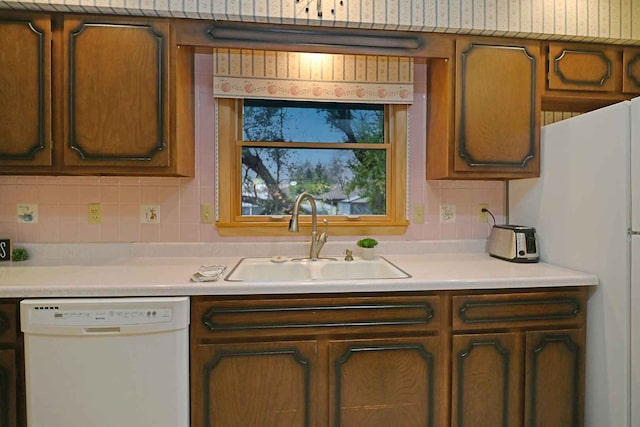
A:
<box><xmin>459</xmin><ymin>43</ymin><xmax>538</xmax><ymax>168</ymax></box>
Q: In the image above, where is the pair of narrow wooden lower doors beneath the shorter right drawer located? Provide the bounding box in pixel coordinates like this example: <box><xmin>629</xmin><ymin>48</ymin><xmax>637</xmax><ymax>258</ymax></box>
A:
<box><xmin>452</xmin><ymin>330</ymin><xmax>585</xmax><ymax>427</ymax></box>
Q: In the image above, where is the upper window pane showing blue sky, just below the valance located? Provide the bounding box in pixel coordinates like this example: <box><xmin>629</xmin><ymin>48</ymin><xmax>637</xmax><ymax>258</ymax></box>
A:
<box><xmin>242</xmin><ymin>99</ymin><xmax>384</xmax><ymax>143</ymax></box>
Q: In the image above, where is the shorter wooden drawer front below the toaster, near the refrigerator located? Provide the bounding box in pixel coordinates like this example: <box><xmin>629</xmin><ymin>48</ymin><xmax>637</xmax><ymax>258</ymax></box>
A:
<box><xmin>452</xmin><ymin>289</ymin><xmax>587</xmax><ymax>330</ymax></box>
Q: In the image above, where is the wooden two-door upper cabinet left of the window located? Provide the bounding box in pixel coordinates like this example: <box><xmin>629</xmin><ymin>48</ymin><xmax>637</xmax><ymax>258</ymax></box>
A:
<box><xmin>0</xmin><ymin>12</ymin><xmax>195</xmax><ymax>176</ymax></box>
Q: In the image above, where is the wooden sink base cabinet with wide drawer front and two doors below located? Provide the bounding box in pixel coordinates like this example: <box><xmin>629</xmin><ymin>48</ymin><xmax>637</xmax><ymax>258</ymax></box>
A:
<box><xmin>191</xmin><ymin>295</ymin><xmax>445</xmax><ymax>427</ymax></box>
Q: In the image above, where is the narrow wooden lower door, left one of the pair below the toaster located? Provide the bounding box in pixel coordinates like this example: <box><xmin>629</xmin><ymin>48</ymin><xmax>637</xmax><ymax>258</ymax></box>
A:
<box><xmin>451</xmin><ymin>333</ymin><xmax>522</xmax><ymax>427</ymax></box>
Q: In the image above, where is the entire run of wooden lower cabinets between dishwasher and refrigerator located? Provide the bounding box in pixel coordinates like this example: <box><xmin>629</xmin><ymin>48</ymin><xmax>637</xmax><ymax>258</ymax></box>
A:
<box><xmin>191</xmin><ymin>287</ymin><xmax>587</xmax><ymax>427</ymax></box>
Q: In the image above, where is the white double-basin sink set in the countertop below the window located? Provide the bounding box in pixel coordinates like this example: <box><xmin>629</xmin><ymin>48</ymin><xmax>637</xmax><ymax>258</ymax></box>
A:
<box><xmin>225</xmin><ymin>257</ymin><xmax>411</xmax><ymax>282</ymax></box>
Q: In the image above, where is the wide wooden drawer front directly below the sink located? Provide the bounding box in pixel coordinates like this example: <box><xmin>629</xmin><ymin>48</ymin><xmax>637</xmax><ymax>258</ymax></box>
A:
<box><xmin>193</xmin><ymin>297</ymin><xmax>440</xmax><ymax>339</ymax></box>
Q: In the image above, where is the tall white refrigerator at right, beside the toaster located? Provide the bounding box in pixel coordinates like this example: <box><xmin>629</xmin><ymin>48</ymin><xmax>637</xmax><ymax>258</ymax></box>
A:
<box><xmin>507</xmin><ymin>98</ymin><xmax>640</xmax><ymax>427</ymax></box>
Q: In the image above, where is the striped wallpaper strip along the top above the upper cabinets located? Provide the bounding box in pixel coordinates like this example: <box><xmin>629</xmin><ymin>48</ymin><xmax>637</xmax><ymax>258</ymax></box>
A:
<box><xmin>0</xmin><ymin>0</ymin><xmax>640</xmax><ymax>44</ymax></box>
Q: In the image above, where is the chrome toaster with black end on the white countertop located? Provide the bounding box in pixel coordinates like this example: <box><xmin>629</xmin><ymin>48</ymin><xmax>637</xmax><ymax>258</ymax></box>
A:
<box><xmin>489</xmin><ymin>224</ymin><xmax>540</xmax><ymax>262</ymax></box>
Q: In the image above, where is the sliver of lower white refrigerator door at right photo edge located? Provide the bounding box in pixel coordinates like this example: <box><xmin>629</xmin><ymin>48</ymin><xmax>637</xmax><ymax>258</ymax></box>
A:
<box><xmin>630</xmin><ymin>235</ymin><xmax>640</xmax><ymax>426</ymax></box>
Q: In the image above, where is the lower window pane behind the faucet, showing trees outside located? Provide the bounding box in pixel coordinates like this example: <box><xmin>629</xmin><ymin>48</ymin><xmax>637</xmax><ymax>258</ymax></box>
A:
<box><xmin>242</xmin><ymin>147</ymin><xmax>387</xmax><ymax>215</ymax></box>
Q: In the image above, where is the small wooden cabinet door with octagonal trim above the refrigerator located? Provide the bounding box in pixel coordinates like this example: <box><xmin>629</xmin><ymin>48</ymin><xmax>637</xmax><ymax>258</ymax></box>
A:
<box><xmin>548</xmin><ymin>43</ymin><xmax>620</xmax><ymax>92</ymax></box>
